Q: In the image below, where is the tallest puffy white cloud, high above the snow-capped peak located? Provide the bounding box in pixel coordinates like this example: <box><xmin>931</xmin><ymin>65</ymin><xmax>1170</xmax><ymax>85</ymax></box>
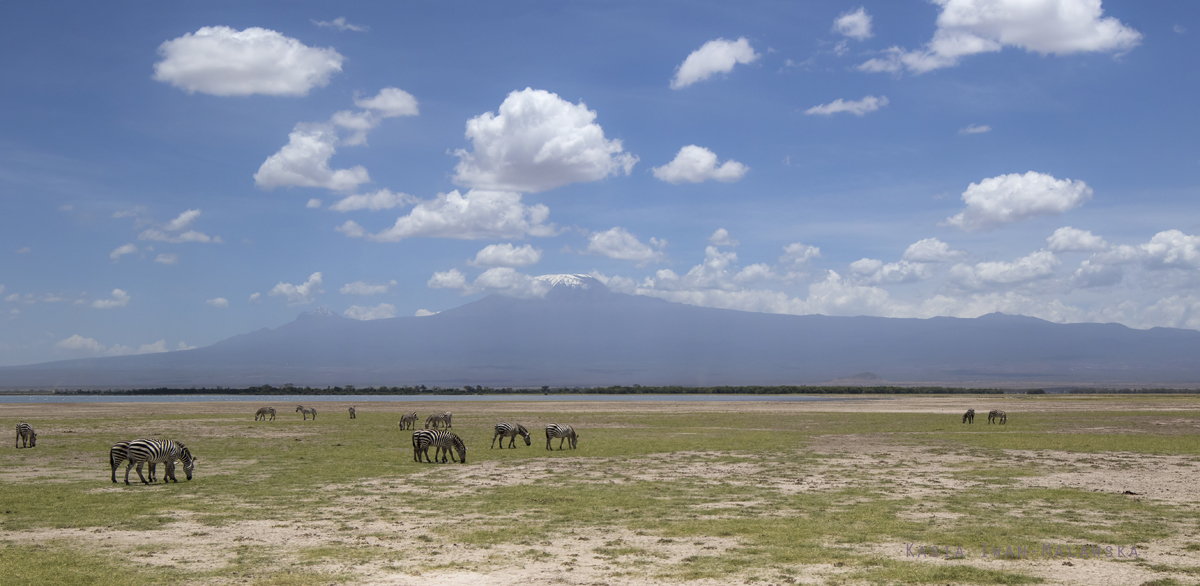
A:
<box><xmin>454</xmin><ymin>88</ymin><xmax>637</xmax><ymax>192</ymax></box>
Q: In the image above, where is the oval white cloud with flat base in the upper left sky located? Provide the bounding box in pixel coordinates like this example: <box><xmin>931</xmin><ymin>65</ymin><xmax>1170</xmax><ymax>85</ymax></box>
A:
<box><xmin>154</xmin><ymin>26</ymin><xmax>343</xmax><ymax>96</ymax></box>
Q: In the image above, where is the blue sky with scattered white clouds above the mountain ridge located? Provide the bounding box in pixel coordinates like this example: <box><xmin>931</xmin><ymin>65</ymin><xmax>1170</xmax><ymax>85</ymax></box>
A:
<box><xmin>0</xmin><ymin>0</ymin><xmax>1200</xmax><ymax>365</ymax></box>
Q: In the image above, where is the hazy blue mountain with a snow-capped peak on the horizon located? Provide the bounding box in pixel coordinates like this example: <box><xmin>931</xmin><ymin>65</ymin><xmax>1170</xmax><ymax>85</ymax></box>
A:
<box><xmin>0</xmin><ymin>275</ymin><xmax>1200</xmax><ymax>388</ymax></box>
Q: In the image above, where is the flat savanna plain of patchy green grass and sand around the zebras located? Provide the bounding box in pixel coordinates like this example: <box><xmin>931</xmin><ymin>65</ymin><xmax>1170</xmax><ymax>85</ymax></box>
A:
<box><xmin>0</xmin><ymin>395</ymin><xmax>1200</xmax><ymax>586</ymax></box>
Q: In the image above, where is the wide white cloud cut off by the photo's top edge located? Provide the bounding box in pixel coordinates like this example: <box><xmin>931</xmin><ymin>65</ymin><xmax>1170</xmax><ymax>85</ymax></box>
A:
<box><xmin>859</xmin><ymin>0</ymin><xmax>1141</xmax><ymax>73</ymax></box>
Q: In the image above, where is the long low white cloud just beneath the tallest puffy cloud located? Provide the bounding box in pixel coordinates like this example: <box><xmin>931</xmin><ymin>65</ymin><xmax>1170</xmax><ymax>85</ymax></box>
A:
<box><xmin>337</xmin><ymin>190</ymin><xmax>557</xmax><ymax>243</ymax></box>
